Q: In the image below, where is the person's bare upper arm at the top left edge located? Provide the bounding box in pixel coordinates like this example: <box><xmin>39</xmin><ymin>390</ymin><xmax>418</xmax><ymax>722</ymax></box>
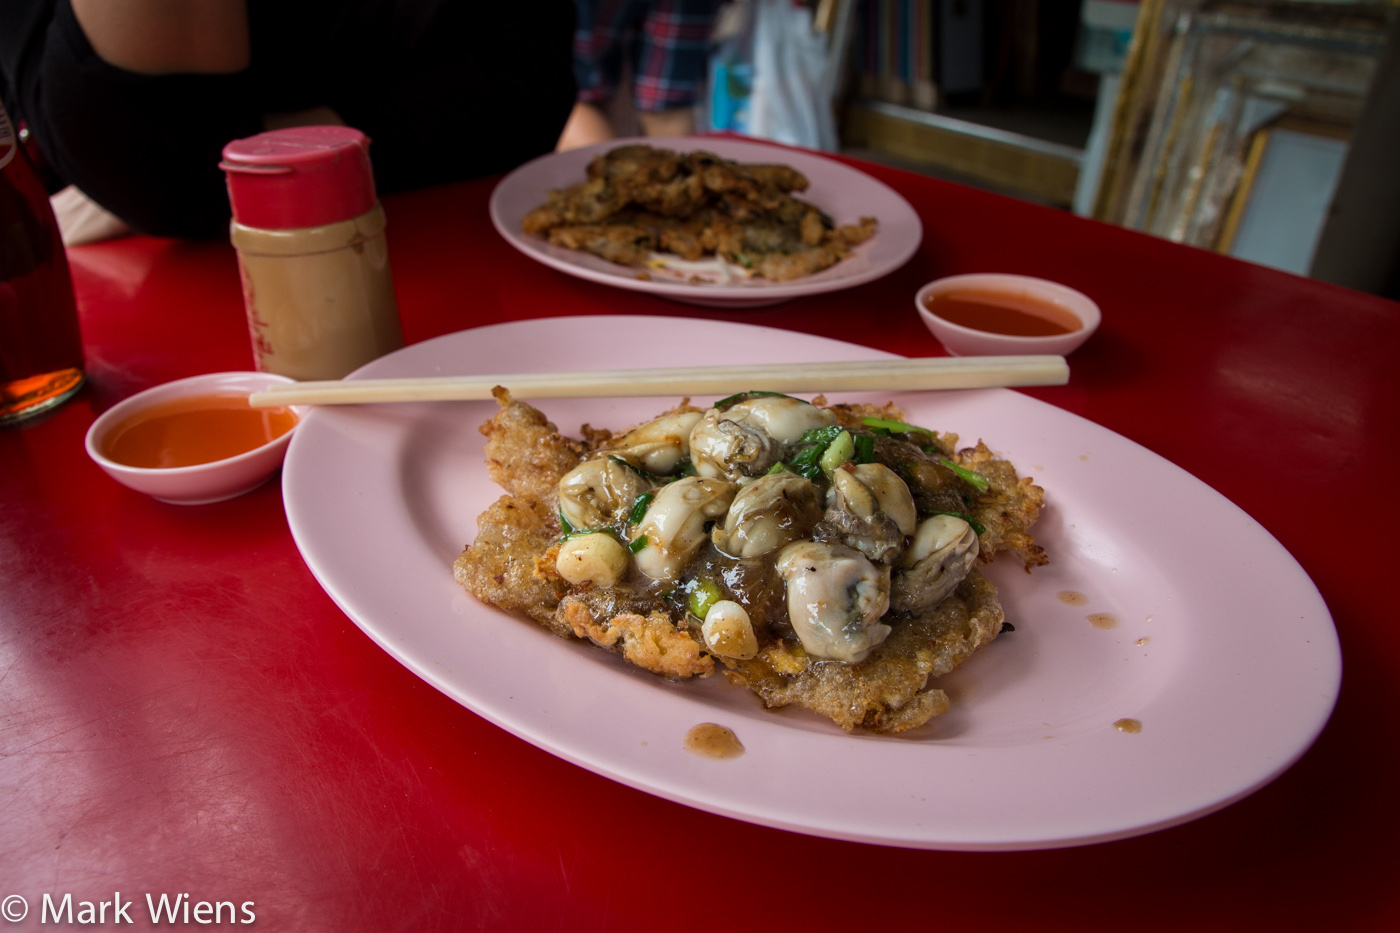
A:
<box><xmin>71</xmin><ymin>0</ymin><xmax>251</xmax><ymax>74</ymax></box>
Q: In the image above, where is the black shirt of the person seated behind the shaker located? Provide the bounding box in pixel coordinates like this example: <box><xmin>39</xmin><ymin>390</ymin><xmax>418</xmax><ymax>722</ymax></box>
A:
<box><xmin>0</xmin><ymin>0</ymin><xmax>574</xmax><ymax>237</ymax></box>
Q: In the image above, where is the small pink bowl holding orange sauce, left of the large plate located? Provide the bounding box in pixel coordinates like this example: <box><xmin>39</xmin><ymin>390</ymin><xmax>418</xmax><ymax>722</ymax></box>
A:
<box><xmin>85</xmin><ymin>373</ymin><xmax>305</xmax><ymax>506</ymax></box>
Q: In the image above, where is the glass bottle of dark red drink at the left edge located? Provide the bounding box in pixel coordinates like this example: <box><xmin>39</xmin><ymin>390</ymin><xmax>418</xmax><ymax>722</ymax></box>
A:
<box><xmin>0</xmin><ymin>100</ymin><xmax>83</xmax><ymax>424</ymax></box>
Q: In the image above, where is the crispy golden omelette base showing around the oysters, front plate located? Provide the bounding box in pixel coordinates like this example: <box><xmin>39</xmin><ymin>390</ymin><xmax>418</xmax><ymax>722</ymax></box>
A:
<box><xmin>454</xmin><ymin>389</ymin><xmax>1047</xmax><ymax>733</ymax></box>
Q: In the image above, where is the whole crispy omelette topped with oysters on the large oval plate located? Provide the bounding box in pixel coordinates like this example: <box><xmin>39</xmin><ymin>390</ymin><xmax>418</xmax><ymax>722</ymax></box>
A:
<box><xmin>454</xmin><ymin>388</ymin><xmax>1047</xmax><ymax>733</ymax></box>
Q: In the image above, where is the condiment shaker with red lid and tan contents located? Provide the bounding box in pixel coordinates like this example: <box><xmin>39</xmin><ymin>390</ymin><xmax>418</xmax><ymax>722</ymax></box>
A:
<box><xmin>220</xmin><ymin>126</ymin><xmax>403</xmax><ymax>380</ymax></box>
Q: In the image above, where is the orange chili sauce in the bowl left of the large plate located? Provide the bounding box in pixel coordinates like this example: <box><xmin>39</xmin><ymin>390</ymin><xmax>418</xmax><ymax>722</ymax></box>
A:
<box><xmin>102</xmin><ymin>394</ymin><xmax>297</xmax><ymax>469</ymax></box>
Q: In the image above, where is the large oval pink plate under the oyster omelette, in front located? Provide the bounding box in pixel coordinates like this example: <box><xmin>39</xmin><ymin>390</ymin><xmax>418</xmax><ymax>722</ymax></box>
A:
<box><xmin>283</xmin><ymin>317</ymin><xmax>1341</xmax><ymax>849</ymax></box>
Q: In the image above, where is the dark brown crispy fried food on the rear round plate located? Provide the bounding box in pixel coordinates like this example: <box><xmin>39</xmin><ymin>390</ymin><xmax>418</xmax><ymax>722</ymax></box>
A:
<box><xmin>522</xmin><ymin>144</ymin><xmax>876</xmax><ymax>282</ymax></box>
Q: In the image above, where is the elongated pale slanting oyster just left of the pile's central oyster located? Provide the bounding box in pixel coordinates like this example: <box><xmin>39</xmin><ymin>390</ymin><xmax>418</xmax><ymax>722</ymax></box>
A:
<box><xmin>631</xmin><ymin>476</ymin><xmax>739</xmax><ymax>583</ymax></box>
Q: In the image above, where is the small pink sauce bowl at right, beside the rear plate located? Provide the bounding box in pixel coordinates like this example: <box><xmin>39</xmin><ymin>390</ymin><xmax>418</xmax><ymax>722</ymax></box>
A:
<box><xmin>914</xmin><ymin>273</ymin><xmax>1103</xmax><ymax>356</ymax></box>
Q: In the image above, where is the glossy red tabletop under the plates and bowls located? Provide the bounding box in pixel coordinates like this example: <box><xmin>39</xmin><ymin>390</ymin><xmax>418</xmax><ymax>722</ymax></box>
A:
<box><xmin>0</xmin><ymin>143</ymin><xmax>1400</xmax><ymax>930</ymax></box>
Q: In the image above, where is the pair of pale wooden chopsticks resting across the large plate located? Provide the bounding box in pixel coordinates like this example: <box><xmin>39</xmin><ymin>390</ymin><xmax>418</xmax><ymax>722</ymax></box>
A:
<box><xmin>248</xmin><ymin>356</ymin><xmax>1070</xmax><ymax>408</ymax></box>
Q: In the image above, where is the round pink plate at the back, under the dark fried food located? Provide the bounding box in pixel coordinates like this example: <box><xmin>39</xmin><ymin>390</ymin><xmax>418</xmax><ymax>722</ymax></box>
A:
<box><xmin>490</xmin><ymin>137</ymin><xmax>923</xmax><ymax>308</ymax></box>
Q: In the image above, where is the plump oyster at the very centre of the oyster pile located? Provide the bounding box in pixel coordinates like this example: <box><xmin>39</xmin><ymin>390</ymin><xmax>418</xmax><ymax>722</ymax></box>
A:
<box><xmin>714</xmin><ymin>474</ymin><xmax>822</xmax><ymax>558</ymax></box>
